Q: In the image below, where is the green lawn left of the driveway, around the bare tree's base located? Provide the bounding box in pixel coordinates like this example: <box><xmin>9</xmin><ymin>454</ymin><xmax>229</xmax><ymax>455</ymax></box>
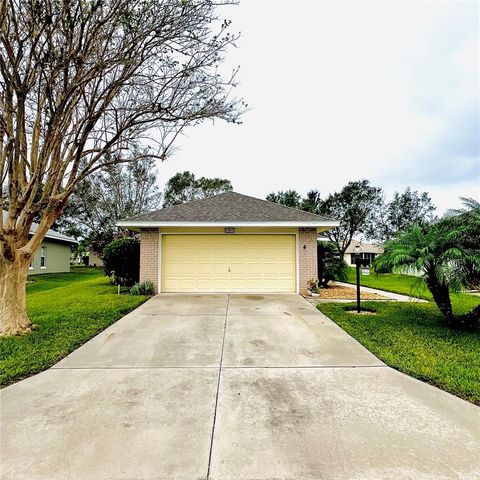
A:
<box><xmin>0</xmin><ymin>267</ymin><xmax>147</xmax><ymax>386</ymax></box>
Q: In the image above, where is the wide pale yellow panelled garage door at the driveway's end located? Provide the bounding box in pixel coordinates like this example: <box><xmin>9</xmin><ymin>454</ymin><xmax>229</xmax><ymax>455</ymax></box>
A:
<box><xmin>162</xmin><ymin>234</ymin><xmax>296</xmax><ymax>293</ymax></box>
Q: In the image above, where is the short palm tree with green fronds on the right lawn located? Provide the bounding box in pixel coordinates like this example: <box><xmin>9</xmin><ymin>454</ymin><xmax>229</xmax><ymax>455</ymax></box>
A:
<box><xmin>375</xmin><ymin>199</ymin><xmax>480</xmax><ymax>327</ymax></box>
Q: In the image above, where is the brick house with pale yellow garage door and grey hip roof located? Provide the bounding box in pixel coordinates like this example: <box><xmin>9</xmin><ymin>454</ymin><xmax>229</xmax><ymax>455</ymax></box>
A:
<box><xmin>118</xmin><ymin>192</ymin><xmax>338</xmax><ymax>293</ymax></box>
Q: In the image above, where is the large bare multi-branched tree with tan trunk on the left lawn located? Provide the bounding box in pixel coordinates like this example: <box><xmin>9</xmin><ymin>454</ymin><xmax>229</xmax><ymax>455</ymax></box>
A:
<box><xmin>0</xmin><ymin>0</ymin><xmax>242</xmax><ymax>335</ymax></box>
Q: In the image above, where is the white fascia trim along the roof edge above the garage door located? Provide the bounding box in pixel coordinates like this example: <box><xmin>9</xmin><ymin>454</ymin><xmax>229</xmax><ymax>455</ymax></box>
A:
<box><xmin>117</xmin><ymin>220</ymin><xmax>340</xmax><ymax>228</ymax></box>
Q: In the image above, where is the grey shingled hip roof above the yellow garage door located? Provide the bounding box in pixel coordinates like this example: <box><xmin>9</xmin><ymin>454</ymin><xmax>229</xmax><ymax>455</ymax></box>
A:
<box><xmin>119</xmin><ymin>192</ymin><xmax>335</xmax><ymax>226</ymax></box>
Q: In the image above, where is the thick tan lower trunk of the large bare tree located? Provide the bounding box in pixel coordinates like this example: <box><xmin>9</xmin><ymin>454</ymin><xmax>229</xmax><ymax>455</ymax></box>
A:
<box><xmin>0</xmin><ymin>255</ymin><xmax>32</xmax><ymax>336</ymax></box>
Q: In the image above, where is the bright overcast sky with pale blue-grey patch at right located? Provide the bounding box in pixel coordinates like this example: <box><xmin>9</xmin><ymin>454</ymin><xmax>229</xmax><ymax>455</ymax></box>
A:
<box><xmin>159</xmin><ymin>0</ymin><xmax>480</xmax><ymax>213</ymax></box>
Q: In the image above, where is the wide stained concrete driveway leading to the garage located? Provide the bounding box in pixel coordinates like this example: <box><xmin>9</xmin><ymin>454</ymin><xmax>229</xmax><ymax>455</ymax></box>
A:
<box><xmin>1</xmin><ymin>295</ymin><xmax>480</xmax><ymax>480</ymax></box>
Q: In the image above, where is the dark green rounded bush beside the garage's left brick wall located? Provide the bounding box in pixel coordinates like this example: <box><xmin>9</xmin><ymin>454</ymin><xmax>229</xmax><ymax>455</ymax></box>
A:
<box><xmin>103</xmin><ymin>237</ymin><xmax>140</xmax><ymax>286</ymax></box>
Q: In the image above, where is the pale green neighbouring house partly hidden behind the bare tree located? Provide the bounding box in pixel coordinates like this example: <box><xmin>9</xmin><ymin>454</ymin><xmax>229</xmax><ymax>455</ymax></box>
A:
<box><xmin>3</xmin><ymin>211</ymin><xmax>78</xmax><ymax>275</ymax></box>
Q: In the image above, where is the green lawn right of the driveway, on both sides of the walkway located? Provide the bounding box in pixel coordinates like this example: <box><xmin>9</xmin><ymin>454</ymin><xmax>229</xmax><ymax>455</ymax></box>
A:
<box><xmin>317</xmin><ymin>274</ymin><xmax>480</xmax><ymax>405</ymax></box>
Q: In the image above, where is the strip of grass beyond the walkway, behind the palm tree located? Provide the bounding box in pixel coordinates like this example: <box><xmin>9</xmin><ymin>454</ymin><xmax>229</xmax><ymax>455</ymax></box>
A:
<box><xmin>347</xmin><ymin>268</ymin><xmax>480</xmax><ymax>315</ymax></box>
